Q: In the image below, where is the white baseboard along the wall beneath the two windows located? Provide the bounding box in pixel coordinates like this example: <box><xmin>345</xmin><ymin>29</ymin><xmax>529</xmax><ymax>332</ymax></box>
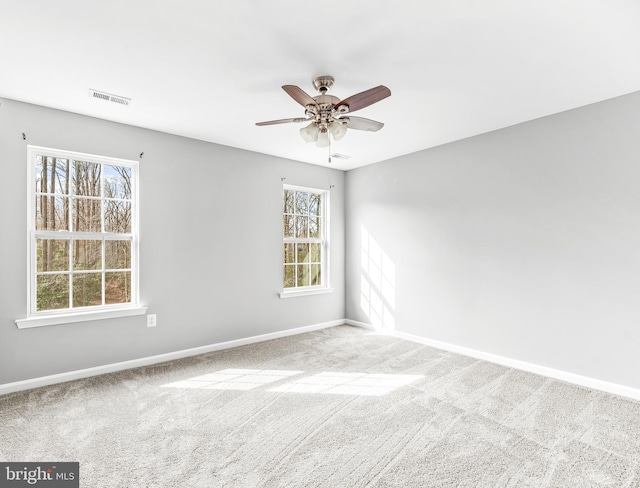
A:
<box><xmin>0</xmin><ymin>320</ymin><xmax>345</xmax><ymax>395</ymax></box>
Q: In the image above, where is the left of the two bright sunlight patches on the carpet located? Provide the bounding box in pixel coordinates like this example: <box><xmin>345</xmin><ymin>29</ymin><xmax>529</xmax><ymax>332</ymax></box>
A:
<box><xmin>162</xmin><ymin>369</ymin><xmax>304</xmax><ymax>390</ymax></box>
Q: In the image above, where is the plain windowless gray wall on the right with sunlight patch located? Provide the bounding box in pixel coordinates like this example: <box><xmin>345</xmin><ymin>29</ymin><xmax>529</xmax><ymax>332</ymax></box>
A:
<box><xmin>346</xmin><ymin>92</ymin><xmax>640</xmax><ymax>388</ymax></box>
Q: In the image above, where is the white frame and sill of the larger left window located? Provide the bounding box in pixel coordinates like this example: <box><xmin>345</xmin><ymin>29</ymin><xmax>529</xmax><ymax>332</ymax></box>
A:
<box><xmin>16</xmin><ymin>145</ymin><xmax>146</xmax><ymax>329</ymax></box>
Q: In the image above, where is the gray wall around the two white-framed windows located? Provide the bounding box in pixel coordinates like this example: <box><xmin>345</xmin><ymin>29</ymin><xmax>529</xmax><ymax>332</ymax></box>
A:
<box><xmin>0</xmin><ymin>100</ymin><xmax>345</xmax><ymax>384</ymax></box>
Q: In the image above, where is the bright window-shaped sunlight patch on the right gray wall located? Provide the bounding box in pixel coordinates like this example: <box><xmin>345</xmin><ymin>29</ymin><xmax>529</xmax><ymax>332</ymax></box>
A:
<box><xmin>360</xmin><ymin>226</ymin><xmax>396</xmax><ymax>332</ymax></box>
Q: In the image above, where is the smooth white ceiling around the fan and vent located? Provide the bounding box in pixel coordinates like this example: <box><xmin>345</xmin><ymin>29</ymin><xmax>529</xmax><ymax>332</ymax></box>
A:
<box><xmin>0</xmin><ymin>0</ymin><xmax>640</xmax><ymax>170</ymax></box>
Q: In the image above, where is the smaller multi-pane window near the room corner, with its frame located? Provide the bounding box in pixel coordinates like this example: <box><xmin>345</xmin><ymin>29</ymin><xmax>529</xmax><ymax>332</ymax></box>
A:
<box><xmin>283</xmin><ymin>185</ymin><xmax>329</xmax><ymax>294</ymax></box>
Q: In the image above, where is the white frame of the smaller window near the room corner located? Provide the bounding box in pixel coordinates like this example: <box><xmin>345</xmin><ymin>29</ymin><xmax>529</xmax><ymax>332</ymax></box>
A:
<box><xmin>279</xmin><ymin>184</ymin><xmax>333</xmax><ymax>298</ymax></box>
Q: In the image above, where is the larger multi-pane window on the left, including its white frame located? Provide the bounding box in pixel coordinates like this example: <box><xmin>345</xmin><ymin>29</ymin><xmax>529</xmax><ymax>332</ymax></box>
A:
<box><xmin>28</xmin><ymin>146</ymin><xmax>138</xmax><ymax>317</ymax></box>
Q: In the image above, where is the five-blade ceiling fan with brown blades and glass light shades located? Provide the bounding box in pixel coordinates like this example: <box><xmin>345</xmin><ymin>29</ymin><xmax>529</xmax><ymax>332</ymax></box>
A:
<box><xmin>256</xmin><ymin>76</ymin><xmax>391</xmax><ymax>147</ymax></box>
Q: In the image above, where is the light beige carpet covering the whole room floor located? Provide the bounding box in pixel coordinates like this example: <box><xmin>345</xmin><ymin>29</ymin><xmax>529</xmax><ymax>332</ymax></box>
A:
<box><xmin>0</xmin><ymin>326</ymin><xmax>640</xmax><ymax>488</ymax></box>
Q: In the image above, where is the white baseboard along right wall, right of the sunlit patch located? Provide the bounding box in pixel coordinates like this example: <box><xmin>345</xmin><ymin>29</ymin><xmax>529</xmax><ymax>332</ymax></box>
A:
<box><xmin>392</xmin><ymin>331</ymin><xmax>640</xmax><ymax>400</ymax></box>
